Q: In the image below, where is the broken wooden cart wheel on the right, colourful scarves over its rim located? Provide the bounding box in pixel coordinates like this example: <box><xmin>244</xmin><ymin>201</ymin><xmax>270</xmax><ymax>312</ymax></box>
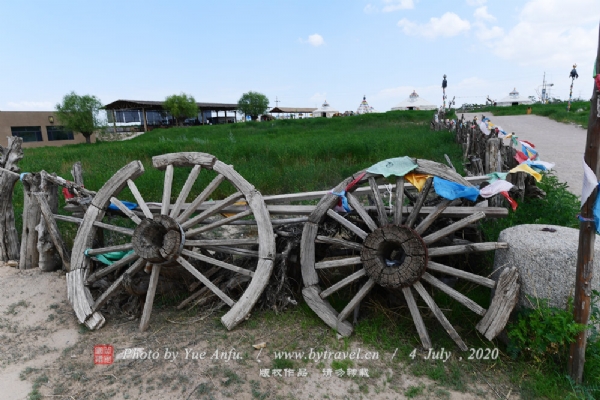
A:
<box><xmin>301</xmin><ymin>159</ymin><xmax>518</xmax><ymax>351</ymax></box>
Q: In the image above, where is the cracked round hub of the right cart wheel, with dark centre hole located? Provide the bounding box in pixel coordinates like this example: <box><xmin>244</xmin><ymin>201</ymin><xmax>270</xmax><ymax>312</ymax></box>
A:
<box><xmin>360</xmin><ymin>225</ymin><xmax>428</xmax><ymax>289</ymax></box>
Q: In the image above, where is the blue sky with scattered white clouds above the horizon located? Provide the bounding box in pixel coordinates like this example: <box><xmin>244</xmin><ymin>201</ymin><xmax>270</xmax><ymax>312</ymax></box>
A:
<box><xmin>0</xmin><ymin>0</ymin><xmax>600</xmax><ymax>112</ymax></box>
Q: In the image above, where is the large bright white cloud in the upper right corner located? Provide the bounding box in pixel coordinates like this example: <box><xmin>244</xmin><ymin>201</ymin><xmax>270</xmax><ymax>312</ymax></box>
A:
<box><xmin>478</xmin><ymin>0</ymin><xmax>600</xmax><ymax>69</ymax></box>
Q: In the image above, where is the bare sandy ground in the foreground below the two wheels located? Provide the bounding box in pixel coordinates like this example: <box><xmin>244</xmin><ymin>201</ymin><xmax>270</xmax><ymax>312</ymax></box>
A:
<box><xmin>0</xmin><ymin>266</ymin><xmax>510</xmax><ymax>400</ymax></box>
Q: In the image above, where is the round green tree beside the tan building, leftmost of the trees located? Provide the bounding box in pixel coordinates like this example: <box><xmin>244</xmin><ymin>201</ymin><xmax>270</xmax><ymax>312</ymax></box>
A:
<box><xmin>55</xmin><ymin>92</ymin><xmax>105</xmax><ymax>143</ymax></box>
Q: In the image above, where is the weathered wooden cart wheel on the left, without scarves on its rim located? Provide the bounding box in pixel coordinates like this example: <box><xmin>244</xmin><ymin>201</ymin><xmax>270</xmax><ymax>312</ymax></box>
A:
<box><xmin>67</xmin><ymin>152</ymin><xmax>275</xmax><ymax>331</ymax></box>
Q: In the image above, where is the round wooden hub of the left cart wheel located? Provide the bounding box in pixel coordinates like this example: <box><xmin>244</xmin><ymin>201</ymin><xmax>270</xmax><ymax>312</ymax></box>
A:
<box><xmin>132</xmin><ymin>215</ymin><xmax>185</xmax><ymax>264</ymax></box>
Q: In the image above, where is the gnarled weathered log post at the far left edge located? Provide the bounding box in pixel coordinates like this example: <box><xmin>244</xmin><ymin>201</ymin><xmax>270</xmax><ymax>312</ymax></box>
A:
<box><xmin>0</xmin><ymin>136</ymin><xmax>23</xmax><ymax>262</ymax></box>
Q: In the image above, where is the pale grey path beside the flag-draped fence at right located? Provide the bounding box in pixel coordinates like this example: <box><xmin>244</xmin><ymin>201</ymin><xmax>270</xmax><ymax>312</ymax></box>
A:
<box><xmin>464</xmin><ymin>113</ymin><xmax>587</xmax><ymax>196</ymax></box>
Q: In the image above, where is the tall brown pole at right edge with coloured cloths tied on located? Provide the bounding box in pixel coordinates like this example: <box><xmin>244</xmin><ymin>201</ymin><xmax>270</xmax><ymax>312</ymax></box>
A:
<box><xmin>569</xmin><ymin>25</ymin><xmax>600</xmax><ymax>383</ymax></box>
